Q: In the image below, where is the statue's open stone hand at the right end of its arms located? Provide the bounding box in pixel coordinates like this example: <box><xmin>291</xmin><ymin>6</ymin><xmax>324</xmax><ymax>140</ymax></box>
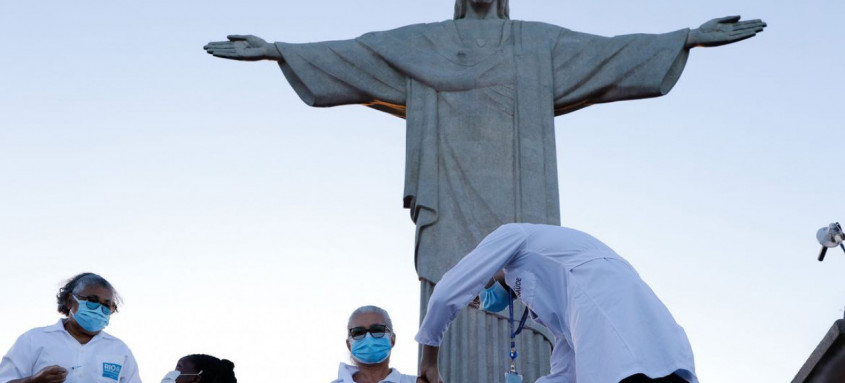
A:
<box><xmin>686</xmin><ymin>16</ymin><xmax>766</xmax><ymax>49</ymax></box>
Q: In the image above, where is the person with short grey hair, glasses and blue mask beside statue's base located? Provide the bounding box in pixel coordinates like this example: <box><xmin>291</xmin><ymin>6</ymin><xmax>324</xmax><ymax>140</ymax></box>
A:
<box><xmin>332</xmin><ymin>306</ymin><xmax>417</xmax><ymax>383</ymax></box>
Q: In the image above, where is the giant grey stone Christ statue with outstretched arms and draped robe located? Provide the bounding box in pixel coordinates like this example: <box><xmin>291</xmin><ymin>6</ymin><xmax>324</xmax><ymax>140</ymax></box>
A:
<box><xmin>204</xmin><ymin>0</ymin><xmax>766</xmax><ymax>383</ymax></box>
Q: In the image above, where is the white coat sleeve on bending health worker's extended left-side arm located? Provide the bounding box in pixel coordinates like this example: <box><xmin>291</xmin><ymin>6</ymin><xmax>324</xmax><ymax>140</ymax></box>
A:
<box><xmin>416</xmin><ymin>224</ymin><xmax>526</xmax><ymax>346</ymax></box>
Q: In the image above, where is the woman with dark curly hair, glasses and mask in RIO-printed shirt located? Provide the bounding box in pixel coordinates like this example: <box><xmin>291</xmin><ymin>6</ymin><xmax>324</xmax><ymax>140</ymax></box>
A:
<box><xmin>0</xmin><ymin>273</ymin><xmax>141</xmax><ymax>383</ymax></box>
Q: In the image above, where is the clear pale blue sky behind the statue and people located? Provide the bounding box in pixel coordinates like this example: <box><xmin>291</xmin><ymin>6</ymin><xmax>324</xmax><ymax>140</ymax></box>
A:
<box><xmin>0</xmin><ymin>0</ymin><xmax>845</xmax><ymax>383</ymax></box>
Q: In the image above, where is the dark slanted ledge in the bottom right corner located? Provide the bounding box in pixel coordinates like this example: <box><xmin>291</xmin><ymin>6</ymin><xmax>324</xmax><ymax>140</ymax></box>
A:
<box><xmin>792</xmin><ymin>319</ymin><xmax>845</xmax><ymax>383</ymax></box>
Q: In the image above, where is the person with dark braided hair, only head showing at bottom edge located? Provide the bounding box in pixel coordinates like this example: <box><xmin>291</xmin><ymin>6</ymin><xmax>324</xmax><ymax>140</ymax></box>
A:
<box><xmin>161</xmin><ymin>354</ymin><xmax>238</xmax><ymax>383</ymax></box>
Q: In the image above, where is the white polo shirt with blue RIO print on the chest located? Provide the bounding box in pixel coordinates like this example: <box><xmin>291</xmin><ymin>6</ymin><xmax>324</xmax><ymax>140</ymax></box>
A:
<box><xmin>0</xmin><ymin>320</ymin><xmax>141</xmax><ymax>383</ymax></box>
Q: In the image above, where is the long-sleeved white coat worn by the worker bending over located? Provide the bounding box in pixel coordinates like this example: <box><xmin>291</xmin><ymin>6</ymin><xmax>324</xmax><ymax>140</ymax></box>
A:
<box><xmin>416</xmin><ymin>224</ymin><xmax>698</xmax><ymax>383</ymax></box>
